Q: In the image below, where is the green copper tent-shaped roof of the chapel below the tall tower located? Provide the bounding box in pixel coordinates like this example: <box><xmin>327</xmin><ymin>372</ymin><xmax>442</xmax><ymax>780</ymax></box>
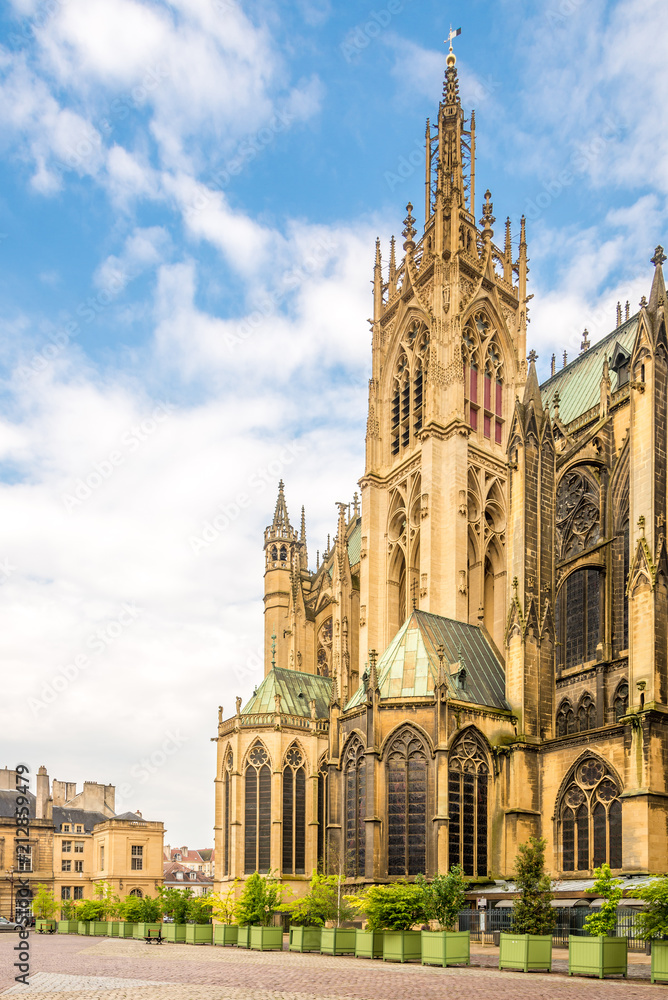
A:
<box><xmin>346</xmin><ymin>611</ymin><xmax>510</xmax><ymax>709</ymax></box>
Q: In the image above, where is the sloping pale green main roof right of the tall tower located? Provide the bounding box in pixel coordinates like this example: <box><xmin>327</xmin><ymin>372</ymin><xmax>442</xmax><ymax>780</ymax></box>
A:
<box><xmin>540</xmin><ymin>313</ymin><xmax>639</xmax><ymax>424</ymax></box>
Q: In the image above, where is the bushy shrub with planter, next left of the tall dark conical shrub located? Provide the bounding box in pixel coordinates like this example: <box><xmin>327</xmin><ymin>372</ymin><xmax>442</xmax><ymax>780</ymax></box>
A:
<box><xmin>418</xmin><ymin>865</ymin><xmax>471</xmax><ymax>966</ymax></box>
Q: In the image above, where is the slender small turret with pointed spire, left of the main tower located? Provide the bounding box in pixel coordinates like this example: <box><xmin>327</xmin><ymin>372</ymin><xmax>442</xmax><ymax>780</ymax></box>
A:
<box><xmin>264</xmin><ymin>479</ymin><xmax>298</xmax><ymax>675</ymax></box>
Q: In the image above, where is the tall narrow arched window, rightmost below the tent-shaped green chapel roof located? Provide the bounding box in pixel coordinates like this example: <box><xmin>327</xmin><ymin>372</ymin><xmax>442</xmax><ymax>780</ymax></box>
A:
<box><xmin>448</xmin><ymin>732</ymin><xmax>489</xmax><ymax>876</ymax></box>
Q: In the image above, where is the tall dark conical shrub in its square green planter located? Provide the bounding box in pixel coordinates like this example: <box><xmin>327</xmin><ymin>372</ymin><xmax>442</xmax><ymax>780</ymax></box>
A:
<box><xmin>499</xmin><ymin>837</ymin><xmax>556</xmax><ymax>972</ymax></box>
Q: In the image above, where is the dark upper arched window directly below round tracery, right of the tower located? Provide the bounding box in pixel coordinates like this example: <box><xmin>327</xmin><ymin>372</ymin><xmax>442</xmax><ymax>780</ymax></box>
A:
<box><xmin>557</xmin><ymin>569</ymin><xmax>603</xmax><ymax>668</ymax></box>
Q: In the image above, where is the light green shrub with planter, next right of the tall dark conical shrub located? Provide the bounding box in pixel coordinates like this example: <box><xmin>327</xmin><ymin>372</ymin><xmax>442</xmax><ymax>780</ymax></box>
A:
<box><xmin>568</xmin><ymin>865</ymin><xmax>628</xmax><ymax>979</ymax></box>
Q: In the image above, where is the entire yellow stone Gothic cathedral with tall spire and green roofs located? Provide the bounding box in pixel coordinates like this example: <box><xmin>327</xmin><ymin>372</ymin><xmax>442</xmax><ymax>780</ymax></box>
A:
<box><xmin>215</xmin><ymin>47</ymin><xmax>668</xmax><ymax>895</ymax></box>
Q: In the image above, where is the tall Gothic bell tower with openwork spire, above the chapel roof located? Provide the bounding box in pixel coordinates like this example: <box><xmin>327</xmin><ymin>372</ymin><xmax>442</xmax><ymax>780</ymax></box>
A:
<box><xmin>360</xmin><ymin>41</ymin><xmax>530</xmax><ymax>667</ymax></box>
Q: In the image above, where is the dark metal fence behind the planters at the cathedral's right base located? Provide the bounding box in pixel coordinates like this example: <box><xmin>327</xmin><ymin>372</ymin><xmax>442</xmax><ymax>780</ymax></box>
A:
<box><xmin>459</xmin><ymin>906</ymin><xmax>645</xmax><ymax>951</ymax></box>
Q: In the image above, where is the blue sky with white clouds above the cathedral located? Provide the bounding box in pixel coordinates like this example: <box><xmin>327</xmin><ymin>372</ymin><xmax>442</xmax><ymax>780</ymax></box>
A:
<box><xmin>0</xmin><ymin>0</ymin><xmax>668</xmax><ymax>847</ymax></box>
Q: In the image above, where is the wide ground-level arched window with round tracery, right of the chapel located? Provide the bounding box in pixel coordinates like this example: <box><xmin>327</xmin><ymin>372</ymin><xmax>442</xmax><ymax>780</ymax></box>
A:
<box><xmin>559</xmin><ymin>756</ymin><xmax>622</xmax><ymax>872</ymax></box>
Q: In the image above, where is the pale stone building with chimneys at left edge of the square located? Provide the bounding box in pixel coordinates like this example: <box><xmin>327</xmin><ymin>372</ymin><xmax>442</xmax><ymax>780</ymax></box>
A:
<box><xmin>0</xmin><ymin>767</ymin><xmax>164</xmax><ymax>917</ymax></box>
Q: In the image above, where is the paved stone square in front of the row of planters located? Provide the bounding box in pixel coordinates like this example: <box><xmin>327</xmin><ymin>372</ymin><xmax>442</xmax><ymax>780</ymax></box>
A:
<box><xmin>0</xmin><ymin>934</ymin><xmax>661</xmax><ymax>1000</ymax></box>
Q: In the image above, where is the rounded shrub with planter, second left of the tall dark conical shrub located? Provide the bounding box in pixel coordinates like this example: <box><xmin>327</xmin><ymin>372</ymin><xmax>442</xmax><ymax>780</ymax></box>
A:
<box><xmin>363</xmin><ymin>881</ymin><xmax>426</xmax><ymax>962</ymax></box>
